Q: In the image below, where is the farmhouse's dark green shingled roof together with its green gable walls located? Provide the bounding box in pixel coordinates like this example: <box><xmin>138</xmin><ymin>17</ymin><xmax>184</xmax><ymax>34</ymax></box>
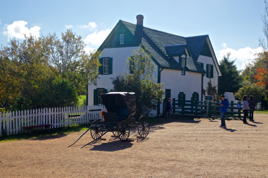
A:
<box><xmin>99</xmin><ymin>20</ymin><xmax>219</xmax><ymax>73</ymax></box>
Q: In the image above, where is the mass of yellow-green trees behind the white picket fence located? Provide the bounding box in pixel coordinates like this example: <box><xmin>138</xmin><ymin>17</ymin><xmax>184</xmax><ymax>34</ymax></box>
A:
<box><xmin>0</xmin><ymin>30</ymin><xmax>100</xmax><ymax>109</ymax></box>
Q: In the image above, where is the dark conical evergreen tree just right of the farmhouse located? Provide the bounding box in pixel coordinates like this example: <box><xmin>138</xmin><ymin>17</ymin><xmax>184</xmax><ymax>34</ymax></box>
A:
<box><xmin>218</xmin><ymin>54</ymin><xmax>243</xmax><ymax>94</ymax></box>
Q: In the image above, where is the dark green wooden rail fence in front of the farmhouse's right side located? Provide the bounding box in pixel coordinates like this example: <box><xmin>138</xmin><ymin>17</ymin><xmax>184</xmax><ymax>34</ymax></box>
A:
<box><xmin>172</xmin><ymin>98</ymin><xmax>242</xmax><ymax>118</ymax></box>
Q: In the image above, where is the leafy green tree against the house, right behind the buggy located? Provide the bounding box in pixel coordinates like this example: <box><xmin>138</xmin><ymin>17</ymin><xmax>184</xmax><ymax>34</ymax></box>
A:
<box><xmin>113</xmin><ymin>46</ymin><xmax>164</xmax><ymax>116</ymax></box>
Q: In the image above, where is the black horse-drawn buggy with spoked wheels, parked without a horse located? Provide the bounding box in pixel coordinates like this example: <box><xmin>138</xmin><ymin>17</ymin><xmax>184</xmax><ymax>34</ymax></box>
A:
<box><xmin>69</xmin><ymin>92</ymin><xmax>150</xmax><ymax>148</ymax></box>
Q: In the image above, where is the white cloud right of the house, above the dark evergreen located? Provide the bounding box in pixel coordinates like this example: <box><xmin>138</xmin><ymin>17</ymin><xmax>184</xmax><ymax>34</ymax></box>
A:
<box><xmin>217</xmin><ymin>43</ymin><xmax>263</xmax><ymax>70</ymax></box>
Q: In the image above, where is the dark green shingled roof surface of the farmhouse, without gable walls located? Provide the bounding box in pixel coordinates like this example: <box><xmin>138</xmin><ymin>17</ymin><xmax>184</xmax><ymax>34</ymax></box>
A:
<box><xmin>99</xmin><ymin>20</ymin><xmax>215</xmax><ymax>73</ymax></box>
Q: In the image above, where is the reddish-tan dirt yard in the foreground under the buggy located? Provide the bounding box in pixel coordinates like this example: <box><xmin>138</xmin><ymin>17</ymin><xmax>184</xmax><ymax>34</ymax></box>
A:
<box><xmin>0</xmin><ymin>114</ymin><xmax>268</xmax><ymax>178</ymax></box>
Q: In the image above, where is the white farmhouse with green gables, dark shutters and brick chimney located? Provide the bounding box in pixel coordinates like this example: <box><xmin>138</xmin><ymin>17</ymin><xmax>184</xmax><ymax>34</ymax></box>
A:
<box><xmin>88</xmin><ymin>15</ymin><xmax>221</xmax><ymax>115</ymax></box>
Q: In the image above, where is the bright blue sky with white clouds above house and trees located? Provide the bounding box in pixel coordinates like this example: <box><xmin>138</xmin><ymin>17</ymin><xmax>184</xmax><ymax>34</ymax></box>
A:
<box><xmin>0</xmin><ymin>0</ymin><xmax>264</xmax><ymax>69</ymax></box>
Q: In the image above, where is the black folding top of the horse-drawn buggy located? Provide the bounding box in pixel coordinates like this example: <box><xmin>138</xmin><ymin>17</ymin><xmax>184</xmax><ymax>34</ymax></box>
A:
<box><xmin>101</xmin><ymin>92</ymin><xmax>136</xmax><ymax>120</ymax></box>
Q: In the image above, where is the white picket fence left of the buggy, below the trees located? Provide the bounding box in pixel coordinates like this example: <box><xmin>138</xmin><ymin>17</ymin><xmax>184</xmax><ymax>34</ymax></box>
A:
<box><xmin>0</xmin><ymin>105</ymin><xmax>106</xmax><ymax>136</ymax></box>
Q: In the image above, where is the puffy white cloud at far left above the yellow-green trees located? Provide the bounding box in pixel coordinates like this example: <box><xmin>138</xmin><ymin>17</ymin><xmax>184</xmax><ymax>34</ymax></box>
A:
<box><xmin>4</xmin><ymin>20</ymin><xmax>41</xmax><ymax>39</ymax></box>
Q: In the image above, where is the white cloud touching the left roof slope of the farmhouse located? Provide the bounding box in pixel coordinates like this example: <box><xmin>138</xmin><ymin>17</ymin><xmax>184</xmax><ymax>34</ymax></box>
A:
<box><xmin>84</xmin><ymin>29</ymin><xmax>111</xmax><ymax>49</ymax></box>
